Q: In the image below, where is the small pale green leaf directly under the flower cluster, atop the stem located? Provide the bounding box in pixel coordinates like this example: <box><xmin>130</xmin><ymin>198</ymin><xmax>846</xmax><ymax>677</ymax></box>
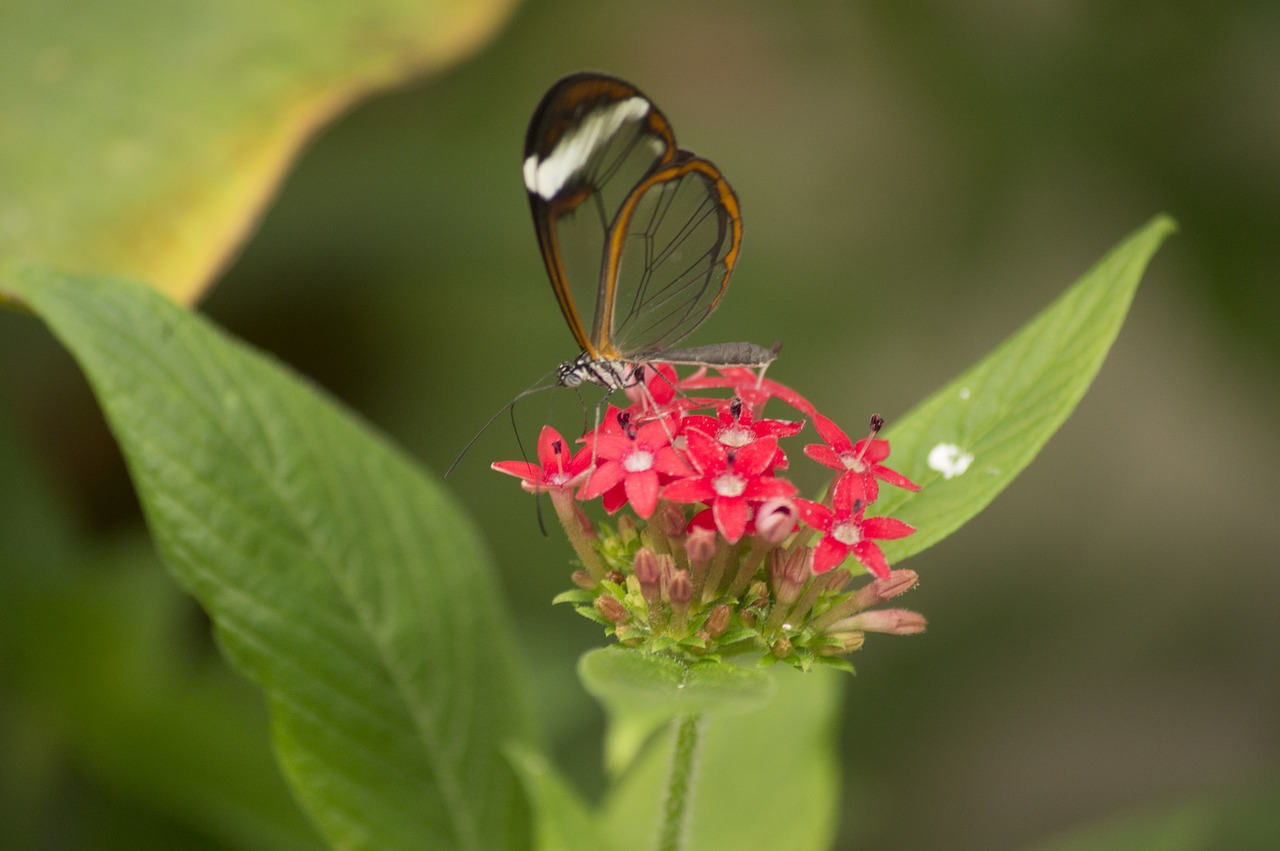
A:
<box><xmin>577</xmin><ymin>646</ymin><xmax>773</xmax><ymax>777</ymax></box>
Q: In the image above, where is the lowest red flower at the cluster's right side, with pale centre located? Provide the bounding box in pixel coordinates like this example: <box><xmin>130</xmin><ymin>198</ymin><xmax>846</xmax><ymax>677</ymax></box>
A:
<box><xmin>795</xmin><ymin>476</ymin><xmax>915</xmax><ymax>580</ymax></box>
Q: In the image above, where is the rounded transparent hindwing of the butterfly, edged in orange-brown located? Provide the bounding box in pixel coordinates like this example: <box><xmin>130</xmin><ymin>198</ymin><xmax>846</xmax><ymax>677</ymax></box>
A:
<box><xmin>604</xmin><ymin>151</ymin><xmax>742</xmax><ymax>360</ymax></box>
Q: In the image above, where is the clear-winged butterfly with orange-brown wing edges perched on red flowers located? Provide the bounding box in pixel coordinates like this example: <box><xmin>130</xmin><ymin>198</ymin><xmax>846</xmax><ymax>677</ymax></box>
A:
<box><xmin>524</xmin><ymin>72</ymin><xmax>777</xmax><ymax>390</ymax></box>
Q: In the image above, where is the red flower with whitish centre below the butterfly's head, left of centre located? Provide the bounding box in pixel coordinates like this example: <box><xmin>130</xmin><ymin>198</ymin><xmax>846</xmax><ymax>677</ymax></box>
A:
<box><xmin>582</xmin><ymin>412</ymin><xmax>691</xmax><ymax>518</ymax></box>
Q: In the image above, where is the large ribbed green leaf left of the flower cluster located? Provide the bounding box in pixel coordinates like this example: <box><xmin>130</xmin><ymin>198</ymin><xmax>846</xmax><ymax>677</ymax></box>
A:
<box><xmin>8</xmin><ymin>270</ymin><xmax>530</xmax><ymax>851</ymax></box>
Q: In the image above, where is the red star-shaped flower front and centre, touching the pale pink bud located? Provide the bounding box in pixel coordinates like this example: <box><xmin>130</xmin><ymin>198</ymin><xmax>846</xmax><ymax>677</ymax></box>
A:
<box><xmin>662</xmin><ymin>430</ymin><xmax>796</xmax><ymax>543</ymax></box>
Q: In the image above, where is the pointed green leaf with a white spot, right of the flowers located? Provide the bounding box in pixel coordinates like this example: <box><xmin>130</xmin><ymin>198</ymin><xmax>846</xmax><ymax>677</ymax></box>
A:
<box><xmin>873</xmin><ymin>216</ymin><xmax>1175</xmax><ymax>563</ymax></box>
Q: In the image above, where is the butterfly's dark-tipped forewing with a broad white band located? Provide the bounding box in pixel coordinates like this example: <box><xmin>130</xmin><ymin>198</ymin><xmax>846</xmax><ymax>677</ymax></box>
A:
<box><xmin>524</xmin><ymin>73</ymin><xmax>676</xmax><ymax>357</ymax></box>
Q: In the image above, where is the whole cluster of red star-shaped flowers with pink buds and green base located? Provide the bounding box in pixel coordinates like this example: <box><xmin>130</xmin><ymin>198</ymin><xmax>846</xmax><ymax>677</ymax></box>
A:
<box><xmin>493</xmin><ymin>365</ymin><xmax>924</xmax><ymax>669</ymax></box>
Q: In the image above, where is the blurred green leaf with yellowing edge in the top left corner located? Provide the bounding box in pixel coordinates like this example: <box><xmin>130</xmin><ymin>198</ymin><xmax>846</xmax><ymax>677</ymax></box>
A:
<box><xmin>0</xmin><ymin>0</ymin><xmax>512</xmax><ymax>302</ymax></box>
